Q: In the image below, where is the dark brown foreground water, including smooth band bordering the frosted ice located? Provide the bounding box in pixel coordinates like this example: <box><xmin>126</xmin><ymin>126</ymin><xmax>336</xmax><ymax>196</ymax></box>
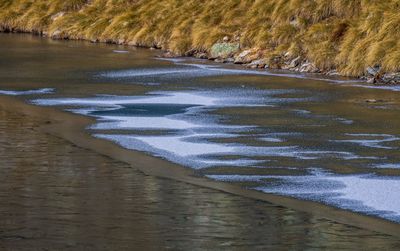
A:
<box><xmin>0</xmin><ymin>93</ymin><xmax>400</xmax><ymax>250</ymax></box>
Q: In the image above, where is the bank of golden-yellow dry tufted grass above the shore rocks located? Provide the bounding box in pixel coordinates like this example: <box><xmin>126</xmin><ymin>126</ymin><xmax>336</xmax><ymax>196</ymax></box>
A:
<box><xmin>0</xmin><ymin>0</ymin><xmax>400</xmax><ymax>79</ymax></box>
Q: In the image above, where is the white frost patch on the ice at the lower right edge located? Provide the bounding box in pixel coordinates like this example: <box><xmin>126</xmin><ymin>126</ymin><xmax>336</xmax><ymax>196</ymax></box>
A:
<box><xmin>207</xmin><ymin>170</ymin><xmax>400</xmax><ymax>222</ymax></box>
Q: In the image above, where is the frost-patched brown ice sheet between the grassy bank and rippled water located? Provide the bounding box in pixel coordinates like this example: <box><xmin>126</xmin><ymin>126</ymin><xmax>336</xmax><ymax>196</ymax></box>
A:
<box><xmin>0</xmin><ymin>34</ymin><xmax>400</xmax><ymax>247</ymax></box>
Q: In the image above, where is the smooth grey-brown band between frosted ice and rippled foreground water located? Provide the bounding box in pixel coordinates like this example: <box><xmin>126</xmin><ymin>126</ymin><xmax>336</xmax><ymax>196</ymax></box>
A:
<box><xmin>0</xmin><ymin>96</ymin><xmax>400</xmax><ymax>238</ymax></box>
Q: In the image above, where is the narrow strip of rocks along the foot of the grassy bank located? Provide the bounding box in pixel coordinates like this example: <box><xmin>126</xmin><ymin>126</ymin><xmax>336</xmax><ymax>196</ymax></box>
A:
<box><xmin>0</xmin><ymin>29</ymin><xmax>400</xmax><ymax>87</ymax></box>
